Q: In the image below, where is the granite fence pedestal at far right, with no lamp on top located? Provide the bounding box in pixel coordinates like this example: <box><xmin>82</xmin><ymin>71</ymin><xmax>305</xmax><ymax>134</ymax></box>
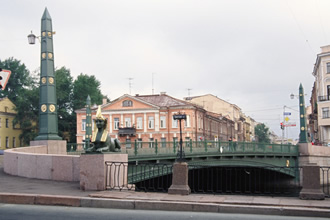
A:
<box><xmin>299</xmin><ymin>164</ymin><xmax>324</xmax><ymax>200</ymax></box>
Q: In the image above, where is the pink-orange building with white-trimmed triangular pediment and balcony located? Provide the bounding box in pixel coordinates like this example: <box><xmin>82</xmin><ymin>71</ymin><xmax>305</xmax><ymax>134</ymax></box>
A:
<box><xmin>76</xmin><ymin>93</ymin><xmax>234</xmax><ymax>143</ymax></box>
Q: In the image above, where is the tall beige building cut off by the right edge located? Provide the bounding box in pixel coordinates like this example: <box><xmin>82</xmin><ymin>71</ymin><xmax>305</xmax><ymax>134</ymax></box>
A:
<box><xmin>309</xmin><ymin>45</ymin><xmax>330</xmax><ymax>145</ymax></box>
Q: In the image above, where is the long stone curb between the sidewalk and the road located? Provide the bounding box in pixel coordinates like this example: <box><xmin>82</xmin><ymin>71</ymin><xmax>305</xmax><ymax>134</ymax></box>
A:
<box><xmin>0</xmin><ymin>193</ymin><xmax>330</xmax><ymax>217</ymax></box>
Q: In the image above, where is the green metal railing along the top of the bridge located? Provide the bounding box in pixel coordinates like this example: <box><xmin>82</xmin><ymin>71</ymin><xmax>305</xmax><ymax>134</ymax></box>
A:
<box><xmin>67</xmin><ymin>140</ymin><xmax>299</xmax><ymax>158</ymax></box>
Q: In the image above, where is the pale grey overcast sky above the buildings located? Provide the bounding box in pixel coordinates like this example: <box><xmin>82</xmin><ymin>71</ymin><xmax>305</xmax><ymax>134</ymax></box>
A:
<box><xmin>0</xmin><ymin>0</ymin><xmax>330</xmax><ymax>138</ymax></box>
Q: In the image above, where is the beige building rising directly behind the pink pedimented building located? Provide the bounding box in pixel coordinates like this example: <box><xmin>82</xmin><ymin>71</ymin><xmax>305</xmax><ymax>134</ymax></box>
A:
<box><xmin>184</xmin><ymin>94</ymin><xmax>255</xmax><ymax>141</ymax></box>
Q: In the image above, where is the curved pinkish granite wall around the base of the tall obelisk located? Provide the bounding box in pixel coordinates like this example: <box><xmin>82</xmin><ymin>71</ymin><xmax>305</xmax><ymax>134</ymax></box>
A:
<box><xmin>3</xmin><ymin>145</ymin><xmax>80</xmax><ymax>181</ymax></box>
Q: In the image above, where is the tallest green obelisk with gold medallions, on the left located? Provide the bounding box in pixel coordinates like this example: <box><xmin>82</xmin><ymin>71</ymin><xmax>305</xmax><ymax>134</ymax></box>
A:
<box><xmin>35</xmin><ymin>8</ymin><xmax>62</xmax><ymax>140</ymax></box>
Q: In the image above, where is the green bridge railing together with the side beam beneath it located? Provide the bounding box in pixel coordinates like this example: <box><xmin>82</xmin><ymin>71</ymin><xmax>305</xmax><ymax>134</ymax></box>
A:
<box><xmin>67</xmin><ymin>140</ymin><xmax>299</xmax><ymax>167</ymax></box>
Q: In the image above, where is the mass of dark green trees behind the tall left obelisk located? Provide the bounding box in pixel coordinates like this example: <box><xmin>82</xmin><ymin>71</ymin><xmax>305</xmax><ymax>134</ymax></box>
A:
<box><xmin>0</xmin><ymin>58</ymin><xmax>103</xmax><ymax>145</ymax></box>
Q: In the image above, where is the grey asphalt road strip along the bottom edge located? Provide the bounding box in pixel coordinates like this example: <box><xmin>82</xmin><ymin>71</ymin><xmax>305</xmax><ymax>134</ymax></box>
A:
<box><xmin>0</xmin><ymin>204</ymin><xmax>329</xmax><ymax>220</ymax></box>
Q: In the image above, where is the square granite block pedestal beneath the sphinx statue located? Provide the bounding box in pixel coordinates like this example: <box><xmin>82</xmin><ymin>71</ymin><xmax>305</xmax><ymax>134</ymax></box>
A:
<box><xmin>79</xmin><ymin>153</ymin><xmax>128</xmax><ymax>191</ymax></box>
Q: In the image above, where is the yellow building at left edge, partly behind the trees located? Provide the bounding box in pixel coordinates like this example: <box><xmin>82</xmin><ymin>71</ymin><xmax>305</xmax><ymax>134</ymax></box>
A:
<box><xmin>0</xmin><ymin>98</ymin><xmax>22</xmax><ymax>150</ymax></box>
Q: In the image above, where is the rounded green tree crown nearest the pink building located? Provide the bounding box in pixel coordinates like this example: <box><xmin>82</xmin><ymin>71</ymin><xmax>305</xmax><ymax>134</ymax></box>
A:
<box><xmin>73</xmin><ymin>73</ymin><xmax>103</xmax><ymax>110</ymax></box>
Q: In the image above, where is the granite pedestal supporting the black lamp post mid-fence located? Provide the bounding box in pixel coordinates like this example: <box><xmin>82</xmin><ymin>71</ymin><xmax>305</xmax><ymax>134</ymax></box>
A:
<box><xmin>168</xmin><ymin>162</ymin><xmax>191</xmax><ymax>195</ymax></box>
